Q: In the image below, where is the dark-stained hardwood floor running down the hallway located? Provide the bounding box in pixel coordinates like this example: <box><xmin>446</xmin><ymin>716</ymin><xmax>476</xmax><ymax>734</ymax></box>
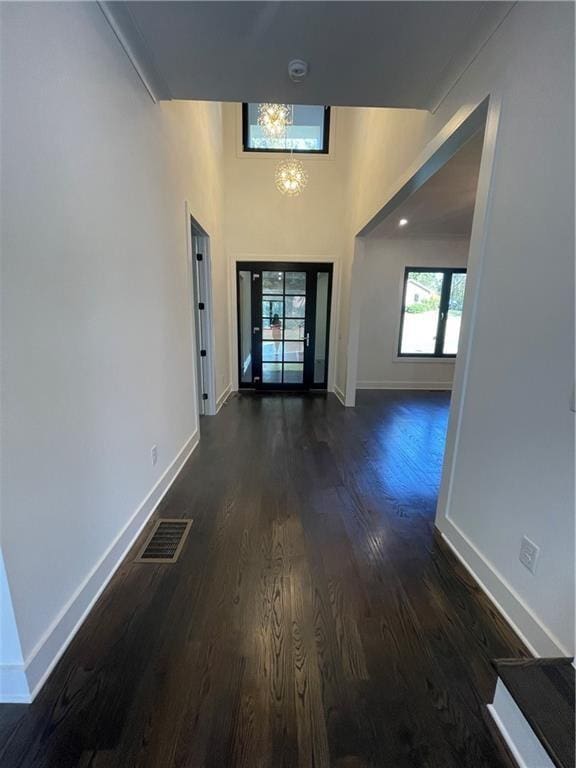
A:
<box><xmin>0</xmin><ymin>392</ymin><xmax>528</xmax><ymax>768</ymax></box>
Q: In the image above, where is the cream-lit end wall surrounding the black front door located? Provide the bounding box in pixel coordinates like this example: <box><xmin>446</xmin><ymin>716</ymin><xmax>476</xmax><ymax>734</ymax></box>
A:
<box><xmin>223</xmin><ymin>104</ymin><xmax>350</xmax><ymax>390</ymax></box>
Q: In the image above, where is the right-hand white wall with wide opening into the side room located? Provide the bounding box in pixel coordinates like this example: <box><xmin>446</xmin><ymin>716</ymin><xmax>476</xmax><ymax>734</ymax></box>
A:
<box><xmin>339</xmin><ymin>2</ymin><xmax>574</xmax><ymax>654</ymax></box>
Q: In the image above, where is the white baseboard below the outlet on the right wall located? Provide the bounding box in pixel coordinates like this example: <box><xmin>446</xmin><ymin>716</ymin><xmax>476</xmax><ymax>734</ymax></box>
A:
<box><xmin>436</xmin><ymin>517</ymin><xmax>573</xmax><ymax>657</ymax></box>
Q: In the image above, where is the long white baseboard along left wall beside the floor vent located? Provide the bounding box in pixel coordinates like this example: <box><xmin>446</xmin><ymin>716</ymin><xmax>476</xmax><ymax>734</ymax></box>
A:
<box><xmin>0</xmin><ymin>430</ymin><xmax>199</xmax><ymax>704</ymax></box>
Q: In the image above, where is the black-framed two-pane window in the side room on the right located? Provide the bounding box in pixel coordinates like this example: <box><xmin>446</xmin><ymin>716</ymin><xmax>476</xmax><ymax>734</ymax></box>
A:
<box><xmin>398</xmin><ymin>267</ymin><xmax>466</xmax><ymax>357</ymax></box>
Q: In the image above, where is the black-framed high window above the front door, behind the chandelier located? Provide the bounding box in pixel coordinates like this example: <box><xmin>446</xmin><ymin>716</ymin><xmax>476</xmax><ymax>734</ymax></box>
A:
<box><xmin>242</xmin><ymin>103</ymin><xmax>330</xmax><ymax>154</ymax></box>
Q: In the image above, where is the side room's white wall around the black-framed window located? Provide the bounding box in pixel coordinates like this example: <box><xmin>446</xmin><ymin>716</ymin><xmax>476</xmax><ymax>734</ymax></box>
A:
<box><xmin>358</xmin><ymin>237</ymin><xmax>469</xmax><ymax>389</ymax></box>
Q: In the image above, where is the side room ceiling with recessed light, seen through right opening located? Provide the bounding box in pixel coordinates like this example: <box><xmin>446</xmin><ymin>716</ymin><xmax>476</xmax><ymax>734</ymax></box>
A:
<box><xmin>370</xmin><ymin>132</ymin><xmax>484</xmax><ymax>238</ymax></box>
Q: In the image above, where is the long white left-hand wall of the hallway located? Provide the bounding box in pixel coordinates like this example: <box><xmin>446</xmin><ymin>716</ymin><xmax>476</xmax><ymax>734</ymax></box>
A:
<box><xmin>0</xmin><ymin>3</ymin><xmax>229</xmax><ymax>704</ymax></box>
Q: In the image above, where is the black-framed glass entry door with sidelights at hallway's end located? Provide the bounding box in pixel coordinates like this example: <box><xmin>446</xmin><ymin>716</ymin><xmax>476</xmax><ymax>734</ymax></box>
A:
<box><xmin>236</xmin><ymin>262</ymin><xmax>332</xmax><ymax>390</ymax></box>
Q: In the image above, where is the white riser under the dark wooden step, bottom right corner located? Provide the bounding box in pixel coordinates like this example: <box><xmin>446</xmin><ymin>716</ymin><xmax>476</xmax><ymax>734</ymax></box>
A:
<box><xmin>487</xmin><ymin>678</ymin><xmax>554</xmax><ymax>768</ymax></box>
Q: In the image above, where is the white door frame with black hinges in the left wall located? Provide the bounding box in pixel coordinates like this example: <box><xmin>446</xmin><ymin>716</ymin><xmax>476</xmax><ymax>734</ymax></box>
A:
<box><xmin>184</xmin><ymin>201</ymin><xmax>216</xmax><ymax>416</ymax></box>
